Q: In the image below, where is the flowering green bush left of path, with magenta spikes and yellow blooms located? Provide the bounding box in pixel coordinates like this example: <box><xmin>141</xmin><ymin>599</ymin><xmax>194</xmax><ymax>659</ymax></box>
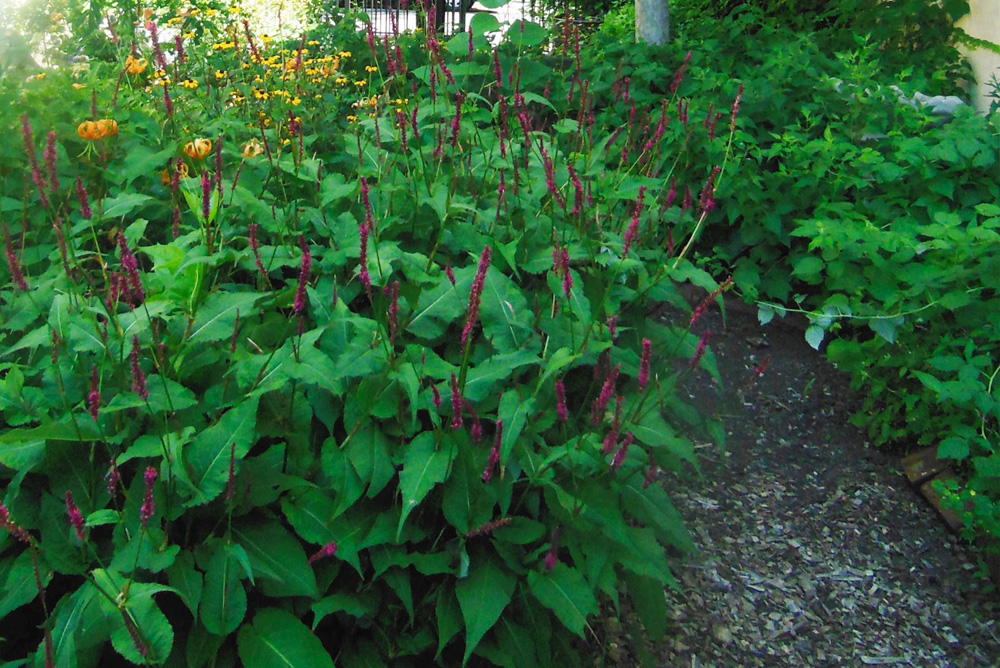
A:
<box><xmin>0</xmin><ymin>3</ymin><xmax>735</xmax><ymax>667</ymax></box>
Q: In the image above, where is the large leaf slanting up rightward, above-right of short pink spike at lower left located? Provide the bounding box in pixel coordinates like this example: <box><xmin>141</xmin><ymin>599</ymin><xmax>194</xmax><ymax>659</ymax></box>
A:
<box><xmin>186</xmin><ymin>398</ymin><xmax>257</xmax><ymax>506</ymax></box>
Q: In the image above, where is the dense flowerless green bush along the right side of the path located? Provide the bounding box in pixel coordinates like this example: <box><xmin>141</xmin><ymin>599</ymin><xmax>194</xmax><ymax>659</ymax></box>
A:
<box><xmin>593</xmin><ymin>3</ymin><xmax>1000</xmax><ymax>568</ymax></box>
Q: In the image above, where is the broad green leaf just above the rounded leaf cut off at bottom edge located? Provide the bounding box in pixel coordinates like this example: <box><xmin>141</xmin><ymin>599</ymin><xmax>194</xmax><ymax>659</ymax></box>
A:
<box><xmin>233</xmin><ymin>522</ymin><xmax>319</xmax><ymax>598</ymax></box>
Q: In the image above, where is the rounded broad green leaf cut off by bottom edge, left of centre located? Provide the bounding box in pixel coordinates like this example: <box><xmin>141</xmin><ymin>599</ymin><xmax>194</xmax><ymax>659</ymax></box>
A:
<box><xmin>237</xmin><ymin>608</ymin><xmax>333</xmax><ymax>668</ymax></box>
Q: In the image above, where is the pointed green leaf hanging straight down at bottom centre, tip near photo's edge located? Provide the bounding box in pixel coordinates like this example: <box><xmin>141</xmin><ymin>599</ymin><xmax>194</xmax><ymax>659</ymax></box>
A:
<box><xmin>455</xmin><ymin>551</ymin><xmax>517</xmax><ymax>665</ymax></box>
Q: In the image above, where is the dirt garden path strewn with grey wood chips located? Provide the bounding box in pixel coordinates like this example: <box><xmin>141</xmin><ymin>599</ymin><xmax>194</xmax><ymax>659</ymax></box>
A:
<box><xmin>605</xmin><ymin>305</ymin><xmax>1000</xmax><ymax>668</ymax></box>
